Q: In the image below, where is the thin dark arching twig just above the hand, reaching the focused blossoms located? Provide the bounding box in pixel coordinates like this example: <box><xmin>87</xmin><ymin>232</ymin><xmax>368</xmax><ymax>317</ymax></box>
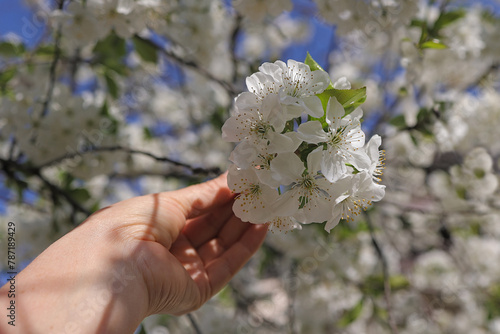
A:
<box><xmin>38</xmin><ymin>145</ymin><xmax>222</xmax><ymax>175</ymax></box>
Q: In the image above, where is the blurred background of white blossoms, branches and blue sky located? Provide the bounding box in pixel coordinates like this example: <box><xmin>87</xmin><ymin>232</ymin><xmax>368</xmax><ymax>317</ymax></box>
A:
<box><xmin>0</xmin><ymin>0</ymin><xmax>500</xmax><ymax>334</ymax></box>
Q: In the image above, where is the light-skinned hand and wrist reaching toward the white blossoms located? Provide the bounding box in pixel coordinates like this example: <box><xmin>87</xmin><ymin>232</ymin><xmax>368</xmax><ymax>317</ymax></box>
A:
<box><xmin>0</xmin><ymin>175</ymin><xmax>267</xmax><ymax>334</ymax></box>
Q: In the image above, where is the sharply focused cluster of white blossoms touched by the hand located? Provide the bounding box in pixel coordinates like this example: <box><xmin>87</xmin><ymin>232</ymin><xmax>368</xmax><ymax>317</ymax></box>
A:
<box><xmin>222</xmin><ymin>60</ymin><xmax>385</xmax><ymax>231</ymax></box>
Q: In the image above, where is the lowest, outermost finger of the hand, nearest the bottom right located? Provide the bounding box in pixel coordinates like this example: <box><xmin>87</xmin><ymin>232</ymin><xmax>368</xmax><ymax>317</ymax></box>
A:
<box><xmin>206</xmin><ymin>224</ymin><xmax>267</xmax><ymax>295</ymax></box>
